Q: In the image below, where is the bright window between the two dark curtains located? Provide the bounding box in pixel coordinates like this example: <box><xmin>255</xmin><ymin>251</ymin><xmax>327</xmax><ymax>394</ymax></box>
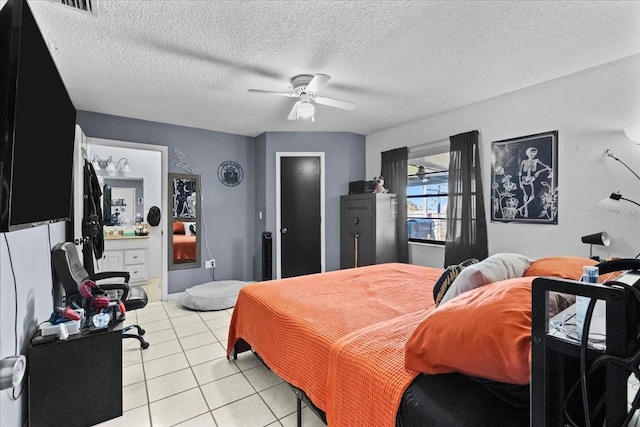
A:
<box><xmin>407</xmin><ymin>151</ymin><xmax>449</xmax><ymax>245</ymax></box>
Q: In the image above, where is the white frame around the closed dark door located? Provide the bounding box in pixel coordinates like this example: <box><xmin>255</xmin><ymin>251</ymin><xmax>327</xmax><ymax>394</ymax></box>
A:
<box><xmin>275</xmin><ymin>152</ymin><xmax>326</xmax><ymax>279</ymax></box>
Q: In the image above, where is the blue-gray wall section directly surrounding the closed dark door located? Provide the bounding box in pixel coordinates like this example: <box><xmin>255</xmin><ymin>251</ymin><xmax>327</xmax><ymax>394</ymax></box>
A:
<box><xmin>259</xmin><ymin>132</ymin><xmax>366</xmax><ymax>277</ymax></box>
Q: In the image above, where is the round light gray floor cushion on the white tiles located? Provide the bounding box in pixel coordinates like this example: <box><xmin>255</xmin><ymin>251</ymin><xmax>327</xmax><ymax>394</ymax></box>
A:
<box><xmin>180</xmin><ymin>280</ymin><xmax>251</xmax><ymax>311</ymax></box>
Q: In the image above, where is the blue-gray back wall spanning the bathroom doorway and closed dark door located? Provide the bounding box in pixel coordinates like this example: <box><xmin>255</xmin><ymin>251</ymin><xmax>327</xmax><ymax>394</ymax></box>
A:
<box><xmin>77</xmin><ymin>111</ymin><xmax>366</xmax><ymax>294</ymax></box>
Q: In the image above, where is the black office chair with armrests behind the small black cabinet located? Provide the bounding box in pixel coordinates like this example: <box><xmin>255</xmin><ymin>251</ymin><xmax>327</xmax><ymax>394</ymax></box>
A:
<box><xmin>51</xmin><ymin>242</ymin><xmax>149</xmax><ymax>350</ymax></box>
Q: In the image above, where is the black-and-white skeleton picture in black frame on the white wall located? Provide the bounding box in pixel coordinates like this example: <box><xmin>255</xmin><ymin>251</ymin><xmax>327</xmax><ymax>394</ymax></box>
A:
<box><xmin>491</xmin><ymin>130</ymin><xmax>558</xmax><ymax>224</ymax></box>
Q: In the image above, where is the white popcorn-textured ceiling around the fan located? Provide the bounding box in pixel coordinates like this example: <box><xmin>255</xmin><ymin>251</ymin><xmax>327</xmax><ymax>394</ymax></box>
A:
<box><xmin>22</xmin><ymin>0</ymin><xmax>640</xmax><ymax>136</ymax></box>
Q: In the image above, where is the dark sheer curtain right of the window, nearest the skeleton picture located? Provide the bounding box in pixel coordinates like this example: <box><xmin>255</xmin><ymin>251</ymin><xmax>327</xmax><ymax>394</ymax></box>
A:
<box><xmin>444</xmin><ymin>130</ymin><xmax>488</xmax><ymax>267</ymax></box>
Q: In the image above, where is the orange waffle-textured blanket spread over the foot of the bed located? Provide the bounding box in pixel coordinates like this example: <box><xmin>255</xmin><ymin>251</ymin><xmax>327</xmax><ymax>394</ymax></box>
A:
<box><xmin>227</xmin><ymin>263</ymin><xmax>442</xmax><ymax>418</ymax></box>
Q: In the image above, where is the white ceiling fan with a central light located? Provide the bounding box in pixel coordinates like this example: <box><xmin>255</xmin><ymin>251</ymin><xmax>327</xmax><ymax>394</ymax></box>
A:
<box><xmin>249</xmin><ymin>74</ymin><xmax>356</xmax><ymax>121</ymax></box>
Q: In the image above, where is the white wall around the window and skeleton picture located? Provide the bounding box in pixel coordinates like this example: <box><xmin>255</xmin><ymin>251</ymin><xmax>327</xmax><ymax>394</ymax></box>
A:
<box><xmin>366</xmin><ymin>55</ymin><xmax>640</xmax><ymax>267</ymax></box>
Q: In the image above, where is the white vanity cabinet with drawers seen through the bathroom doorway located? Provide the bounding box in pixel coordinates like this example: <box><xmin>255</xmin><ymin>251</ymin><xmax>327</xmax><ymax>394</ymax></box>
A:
<box><xmin>98</xmin><ymin>236</ymin><xmax>149</xmax><ymax>285</ymax></box>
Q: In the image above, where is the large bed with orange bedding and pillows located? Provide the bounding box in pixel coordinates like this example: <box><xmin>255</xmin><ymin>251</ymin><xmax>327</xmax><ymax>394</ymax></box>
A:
<box><xmin>227</xmin><ymin>257</ymin><xmax>590</xmax><ymax>427</ymax></box>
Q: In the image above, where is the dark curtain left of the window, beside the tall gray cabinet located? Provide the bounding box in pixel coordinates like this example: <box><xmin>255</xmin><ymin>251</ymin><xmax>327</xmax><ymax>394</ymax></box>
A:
<box><xmin>380</xmin><ymin>147</ymin><xmax>409</xmax><ymax>263</ymax></box>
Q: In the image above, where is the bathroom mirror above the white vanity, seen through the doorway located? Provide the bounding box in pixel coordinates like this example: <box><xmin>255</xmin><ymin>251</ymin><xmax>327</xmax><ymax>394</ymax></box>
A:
<box><xmin>102</xmin><ymin>177</ymin><xmax>144</xmax><ymax>226</ymax></box>
